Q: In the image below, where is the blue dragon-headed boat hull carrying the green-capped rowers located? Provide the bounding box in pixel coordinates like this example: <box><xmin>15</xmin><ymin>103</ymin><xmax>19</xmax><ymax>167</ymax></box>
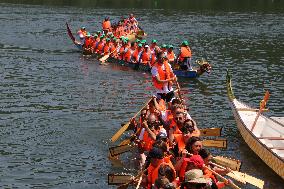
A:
<box><xmin>66</xmin><ymin>23</ymin><xmax>212</xmax><ymax>78</ymax></box>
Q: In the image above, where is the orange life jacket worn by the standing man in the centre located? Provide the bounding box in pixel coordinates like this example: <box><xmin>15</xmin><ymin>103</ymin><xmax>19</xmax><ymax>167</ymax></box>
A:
<box><xmin>152</xmin><ymin>61</ymin><xmax>174</xmax><ymax>90</ymax></box>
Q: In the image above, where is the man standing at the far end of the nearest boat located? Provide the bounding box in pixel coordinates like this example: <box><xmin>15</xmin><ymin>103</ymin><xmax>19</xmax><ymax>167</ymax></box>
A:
<box><xmin>151</xmin><ymin>52</ymin><xmax>176</xmax><ymax>102</ymax></box>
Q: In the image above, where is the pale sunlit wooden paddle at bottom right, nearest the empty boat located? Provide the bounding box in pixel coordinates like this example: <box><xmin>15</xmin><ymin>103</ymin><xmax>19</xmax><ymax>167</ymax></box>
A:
<box><xmin>210</xmin><ymin>162</ymin><xmax>264</xmax><ymax>188</ymax></box>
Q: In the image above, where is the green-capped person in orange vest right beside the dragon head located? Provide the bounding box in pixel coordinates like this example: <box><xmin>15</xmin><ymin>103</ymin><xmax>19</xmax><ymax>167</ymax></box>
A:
<box><xmin>178</xmin><ymin>41</ymin><xmax>192</xmax><ymax>70</ymax></box>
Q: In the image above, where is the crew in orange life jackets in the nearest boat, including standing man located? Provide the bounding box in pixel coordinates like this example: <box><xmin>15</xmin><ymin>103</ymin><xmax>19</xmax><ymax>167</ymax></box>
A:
<box><xmin>111</xmin><ymin>48</ymin><xmax>235</xmax><ymax>189</ymax></box>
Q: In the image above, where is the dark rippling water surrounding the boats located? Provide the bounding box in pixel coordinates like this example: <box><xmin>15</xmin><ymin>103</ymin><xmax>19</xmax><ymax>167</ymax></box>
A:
<box><xmin>0</xmin><ymin>0</ymin><xmax>284</xmax><ymax>189</ymax></box>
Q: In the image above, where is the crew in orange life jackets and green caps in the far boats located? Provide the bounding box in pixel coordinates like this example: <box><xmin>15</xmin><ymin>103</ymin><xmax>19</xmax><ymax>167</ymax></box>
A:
<box><xmin>78</xmin><ymin>14</ymin><xmax>192</xmax><ymax>70</ymax></box>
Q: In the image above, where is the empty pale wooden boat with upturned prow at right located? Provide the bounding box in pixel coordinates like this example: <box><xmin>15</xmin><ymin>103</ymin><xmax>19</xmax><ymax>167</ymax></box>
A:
<box><xmin>227</xmin><ymin>70</ymin><xmax>284</xmax><ymax>179</ymax></box>
